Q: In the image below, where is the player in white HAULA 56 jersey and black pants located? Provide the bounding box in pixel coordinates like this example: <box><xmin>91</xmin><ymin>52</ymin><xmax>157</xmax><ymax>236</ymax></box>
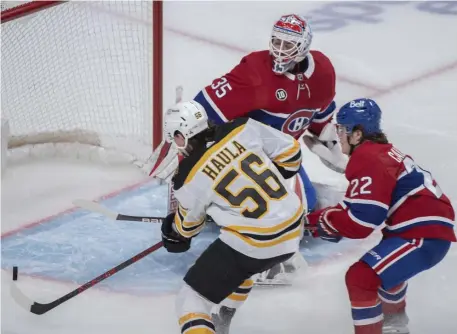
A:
<box><xmin>162</xmin><ymin>101</ymin><xmax>304</xmax><ymax>334</ymax></box>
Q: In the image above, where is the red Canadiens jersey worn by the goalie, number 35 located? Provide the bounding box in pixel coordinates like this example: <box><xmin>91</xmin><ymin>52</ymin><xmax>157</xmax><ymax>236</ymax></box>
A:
<box><xmin>195</xmin><ymin>51</ymin><xmax>336</xmax><ymax>138</ymax></box>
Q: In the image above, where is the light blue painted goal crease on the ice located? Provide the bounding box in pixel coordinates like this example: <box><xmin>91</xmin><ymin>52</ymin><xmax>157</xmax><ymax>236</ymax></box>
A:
<box><xmin>1</xmin><ymin>182</ymin><xmax>356</xmax><ymax>295</ymax></box>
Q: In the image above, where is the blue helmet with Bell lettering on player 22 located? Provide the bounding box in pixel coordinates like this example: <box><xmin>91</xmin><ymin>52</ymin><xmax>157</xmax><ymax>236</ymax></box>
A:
<box><xmin>336</xmin><ymin>99</ymin><xmax>381</xmax><ymax>135</ymax></box>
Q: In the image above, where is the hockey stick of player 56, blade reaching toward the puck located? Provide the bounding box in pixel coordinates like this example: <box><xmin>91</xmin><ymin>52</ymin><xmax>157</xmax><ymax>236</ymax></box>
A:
<box><xmin>10</xmin><ymin>241</ymin><xmax>162</xmax><ymax>315</ymax></box>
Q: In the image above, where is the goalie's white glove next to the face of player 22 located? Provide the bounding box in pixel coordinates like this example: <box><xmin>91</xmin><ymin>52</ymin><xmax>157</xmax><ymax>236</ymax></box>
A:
<box><xmin>303</xmin><ymin>123</ymin><xmax>348</xmax><ymax>174</ymax></box>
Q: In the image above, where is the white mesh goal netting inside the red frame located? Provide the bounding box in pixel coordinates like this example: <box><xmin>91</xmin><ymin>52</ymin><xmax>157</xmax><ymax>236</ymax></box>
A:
<box><xmin>1</xmin><ymin>1</ymin><xmax>153</xmax><ymax>165</ymax></box>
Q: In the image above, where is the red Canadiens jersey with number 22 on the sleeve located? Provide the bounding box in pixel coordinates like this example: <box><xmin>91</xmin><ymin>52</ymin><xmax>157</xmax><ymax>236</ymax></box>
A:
<box><xmin>326</xmin><ymin>141</ymin><xmax>456</xmax><ymax>241</ymax></box>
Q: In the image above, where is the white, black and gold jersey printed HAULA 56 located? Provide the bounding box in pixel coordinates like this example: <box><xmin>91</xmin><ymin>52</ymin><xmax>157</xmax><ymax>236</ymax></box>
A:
<box><xmin>173</xmin><ymin>118</ymin><xmax>303</xmax><ymax>259</ymax></box>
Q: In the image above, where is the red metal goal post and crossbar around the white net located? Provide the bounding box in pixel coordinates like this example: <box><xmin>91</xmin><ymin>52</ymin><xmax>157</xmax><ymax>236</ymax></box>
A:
<box><xmin>1</xmin><ymin>0</ymin><xmax>163</xmax><ymax>149</ymax></box>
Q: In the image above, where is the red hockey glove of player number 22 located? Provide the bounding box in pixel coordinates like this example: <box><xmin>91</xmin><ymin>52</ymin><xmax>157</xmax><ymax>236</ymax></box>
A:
<box><xmin>305</xmin><ymin>207</ymin><xmax>342</xmax><ymax>242</ymax></box>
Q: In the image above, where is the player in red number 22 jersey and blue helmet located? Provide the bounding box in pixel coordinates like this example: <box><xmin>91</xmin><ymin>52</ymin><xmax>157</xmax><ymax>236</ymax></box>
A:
<box><xmin>307</xmin><ymin>99</ymin><xmax>456</xmax><ymax>334</ymax></box>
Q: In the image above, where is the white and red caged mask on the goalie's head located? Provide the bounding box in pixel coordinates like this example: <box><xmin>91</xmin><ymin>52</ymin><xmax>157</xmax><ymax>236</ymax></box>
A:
<box><xmin>270</xmin><ymin>14</ymin><xmax>313</xmax><ymax>74</ymax></box>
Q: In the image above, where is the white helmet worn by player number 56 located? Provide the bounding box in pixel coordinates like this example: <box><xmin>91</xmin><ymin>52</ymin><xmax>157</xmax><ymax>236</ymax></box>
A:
<box><xmin>164</xmin><ymin>101</ymin><xmax>208</xmax><ymax>150</ymax></box>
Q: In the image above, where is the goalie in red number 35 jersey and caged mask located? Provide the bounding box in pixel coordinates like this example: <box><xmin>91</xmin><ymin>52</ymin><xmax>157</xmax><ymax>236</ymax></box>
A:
<box><xmin>194</xmin><ymin>14</ymin><xmax>346</xmax><ymax>211</ymax></box>
